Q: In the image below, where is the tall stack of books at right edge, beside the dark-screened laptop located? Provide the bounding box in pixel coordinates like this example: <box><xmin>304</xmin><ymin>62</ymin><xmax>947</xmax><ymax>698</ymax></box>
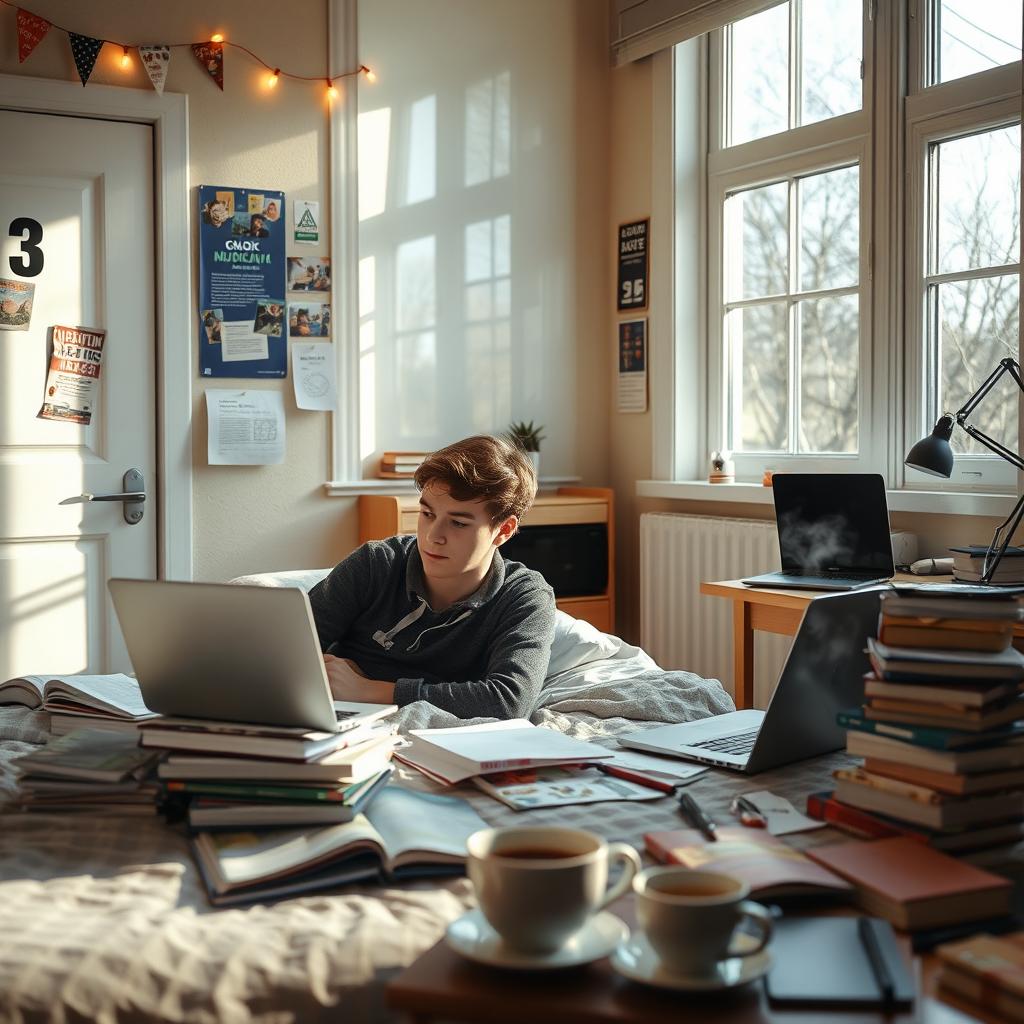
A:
<box><xmin>823</xmin><ymin>594</ymin><xmax>1024</xmax><ymax>852</ymax></box>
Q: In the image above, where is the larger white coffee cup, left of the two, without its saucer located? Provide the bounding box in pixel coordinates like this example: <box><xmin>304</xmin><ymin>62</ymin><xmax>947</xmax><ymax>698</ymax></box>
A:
<box><xmin>466</xmin><ymin>826</ymin><xmax>640</xmax><ymax>952</ymax></box>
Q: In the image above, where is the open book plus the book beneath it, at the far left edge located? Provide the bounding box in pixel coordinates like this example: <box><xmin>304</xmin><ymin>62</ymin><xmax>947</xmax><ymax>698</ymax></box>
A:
<box><xmin>0</xmin><ymin>673</ymin><xmax>159</xmax><ymax>741</ymax></box>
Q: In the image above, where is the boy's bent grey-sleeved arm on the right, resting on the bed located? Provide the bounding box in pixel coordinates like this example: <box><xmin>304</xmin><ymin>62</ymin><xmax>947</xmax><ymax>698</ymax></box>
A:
<box><xmin>393</xmin><ymin>587</ymin><xmax>555</xmax><ymax>719</ymax></box>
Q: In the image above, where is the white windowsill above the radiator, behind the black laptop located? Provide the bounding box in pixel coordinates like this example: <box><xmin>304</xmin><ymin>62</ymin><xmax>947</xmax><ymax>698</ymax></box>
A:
<box><xmin>636</xmin><ymin>480</ymin><xmax>1017</xmax><ymax>516</ymax></box>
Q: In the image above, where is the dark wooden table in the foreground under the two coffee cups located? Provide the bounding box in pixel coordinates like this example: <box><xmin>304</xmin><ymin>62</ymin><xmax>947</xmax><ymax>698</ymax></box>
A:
<box><xmin>387</xmin><ymin>900</ymin><xmax>978</xmax><ymax>1024</ymax></box>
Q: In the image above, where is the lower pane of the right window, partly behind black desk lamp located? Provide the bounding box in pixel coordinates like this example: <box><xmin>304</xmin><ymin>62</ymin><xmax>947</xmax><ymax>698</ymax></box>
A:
<box><xmin>933</xmin><ymin>273</ymin><xmax>1020</xmax><ymax>454</ymax></box>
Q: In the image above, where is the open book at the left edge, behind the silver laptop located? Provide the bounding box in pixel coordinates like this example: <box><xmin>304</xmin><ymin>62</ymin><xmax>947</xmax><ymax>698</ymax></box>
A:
<box><xmin>0</xmin><ymin>673</ymin><xmax>159</xmax><ymax>724</ymax></box>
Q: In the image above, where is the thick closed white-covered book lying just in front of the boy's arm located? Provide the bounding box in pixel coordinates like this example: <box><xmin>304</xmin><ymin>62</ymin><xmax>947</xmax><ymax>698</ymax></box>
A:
<box><xmin>394</xmin><ymin>719</ymin><xmax>614</xmax><ymax>785</ymax></box>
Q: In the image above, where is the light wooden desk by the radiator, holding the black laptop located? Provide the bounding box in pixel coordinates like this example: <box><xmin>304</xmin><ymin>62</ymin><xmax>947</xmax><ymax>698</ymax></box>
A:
<box><xmin>700</xmin><ymin>572</ymin><xmax>929</xmax><ymax>708</ymax></box>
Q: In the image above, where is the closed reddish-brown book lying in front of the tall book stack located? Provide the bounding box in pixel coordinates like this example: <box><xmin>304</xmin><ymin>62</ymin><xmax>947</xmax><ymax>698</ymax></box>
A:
<box><xmin>807</xmin><ymin>837</ymin><xmax>1012</xmax><ymax>930</ymax></box>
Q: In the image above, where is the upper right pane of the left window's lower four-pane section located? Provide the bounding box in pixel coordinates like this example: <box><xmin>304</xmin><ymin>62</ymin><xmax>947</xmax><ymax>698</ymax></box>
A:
<box><xmin>798</xmin><ymin>167</ymin><xmax>860</xmax><ymax>292</ymax></box>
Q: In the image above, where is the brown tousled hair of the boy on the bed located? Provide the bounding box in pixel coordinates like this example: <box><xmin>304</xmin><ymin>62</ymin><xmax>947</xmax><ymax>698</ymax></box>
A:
<box><xmin>414</xmin><ymin>434</ymin><xmax>537</xmax><ymax>523</ymax></box>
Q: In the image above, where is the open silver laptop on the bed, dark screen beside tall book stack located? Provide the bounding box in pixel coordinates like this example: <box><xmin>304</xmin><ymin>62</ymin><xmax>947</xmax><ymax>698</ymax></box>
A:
<box><xmin>618</xmin><ymin>588</ymin><xmax>882</xmax><ymax>774</ymax></box>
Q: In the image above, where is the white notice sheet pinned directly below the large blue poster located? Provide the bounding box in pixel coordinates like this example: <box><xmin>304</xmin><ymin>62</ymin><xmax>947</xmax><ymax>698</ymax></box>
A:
<box><xmin>206</xmin><ymin>389</ymin><xmax>285</xmax><ymax>466</ymax></box>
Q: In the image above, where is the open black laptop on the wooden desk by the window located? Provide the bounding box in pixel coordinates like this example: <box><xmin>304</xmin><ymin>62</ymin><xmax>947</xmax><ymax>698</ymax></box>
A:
<box><xmin>741</xmin><ymin>473</ymin><xmax>895</xmax><ymax>591</ymax></box>
